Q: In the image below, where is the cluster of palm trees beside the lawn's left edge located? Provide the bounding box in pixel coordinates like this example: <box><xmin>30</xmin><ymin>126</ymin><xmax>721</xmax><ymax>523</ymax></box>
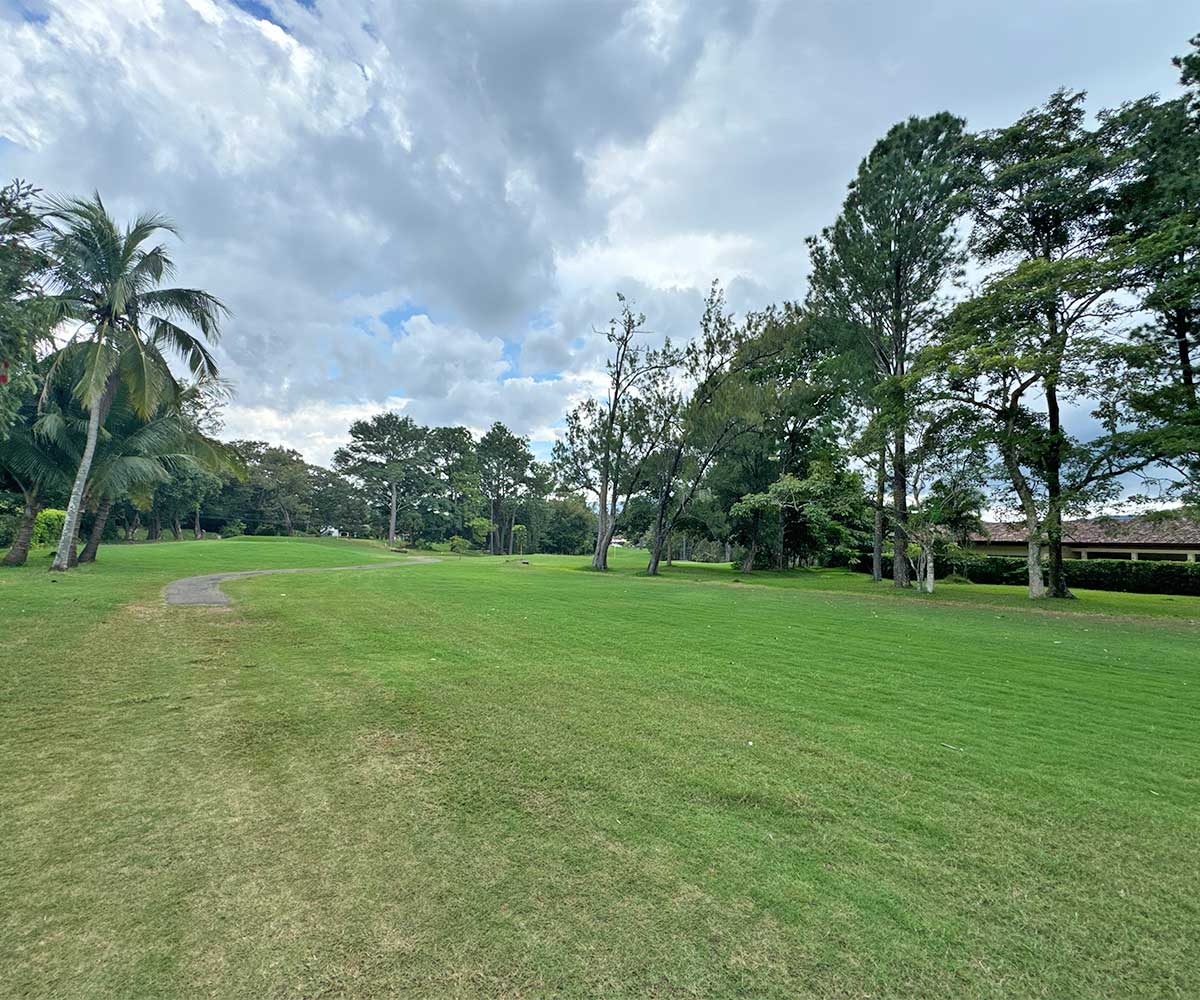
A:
<box><xmin>0</xmin><ymin>194</ymin><xmax>233</xmax><ymax>573</ymax></box>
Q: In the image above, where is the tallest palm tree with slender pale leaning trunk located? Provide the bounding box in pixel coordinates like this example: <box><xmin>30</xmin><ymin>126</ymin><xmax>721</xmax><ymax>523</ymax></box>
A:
<box><xmin>43</xmin><ymin>193</ymin><xmax>228</xmax><ymax>571</ymax></box>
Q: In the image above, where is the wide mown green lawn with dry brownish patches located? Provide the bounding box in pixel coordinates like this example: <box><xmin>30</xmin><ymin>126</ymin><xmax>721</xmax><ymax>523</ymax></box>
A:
<box><xmin>0</xmin><ymin>541</ymin><xmax>1200</xmax><ymax>998</ymax></box>
